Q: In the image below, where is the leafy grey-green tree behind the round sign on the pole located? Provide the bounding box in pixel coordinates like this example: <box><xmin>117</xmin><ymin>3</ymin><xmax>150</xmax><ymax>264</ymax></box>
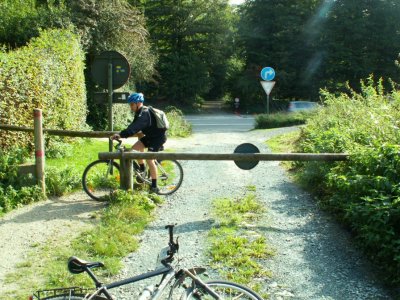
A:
<box><xmin>64</xmin><ymin>0</ymin><xmax>156</xmax><ymax>128</ymax></box>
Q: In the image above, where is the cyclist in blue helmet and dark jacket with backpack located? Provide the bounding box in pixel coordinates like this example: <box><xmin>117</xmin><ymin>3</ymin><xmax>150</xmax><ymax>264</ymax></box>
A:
<box><xmin>110</xmin><ymin>93</ymin><xmax>167</xmax><ymax>192</ymax></box>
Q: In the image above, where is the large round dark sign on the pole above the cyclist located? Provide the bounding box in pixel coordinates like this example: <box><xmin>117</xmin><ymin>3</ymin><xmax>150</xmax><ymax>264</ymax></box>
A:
<box><xmin>91</xmin><ymin>51</ymin><xmax>131</xmax><ymax>89</ymax></box>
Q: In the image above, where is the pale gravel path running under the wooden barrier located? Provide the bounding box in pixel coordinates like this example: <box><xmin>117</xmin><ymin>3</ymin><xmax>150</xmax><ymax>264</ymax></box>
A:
<box><xmin>0</xmin><ymin>128</ymin><xmax>395</xmax><ymax>299</ymax></box>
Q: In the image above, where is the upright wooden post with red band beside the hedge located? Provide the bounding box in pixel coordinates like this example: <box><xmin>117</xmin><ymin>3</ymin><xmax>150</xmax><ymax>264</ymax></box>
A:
<box><xmin>33</xmin><ymin>108</ymin><xmax>46</xmax><ymax>197</ymax></box>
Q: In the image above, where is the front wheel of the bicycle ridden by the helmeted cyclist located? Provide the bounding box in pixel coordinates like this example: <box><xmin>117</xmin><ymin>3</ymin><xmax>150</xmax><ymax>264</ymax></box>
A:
<box><xmin>82</xmin><ymin>160</ymin><xmax>120</xmax><ymax>201</ymax></box>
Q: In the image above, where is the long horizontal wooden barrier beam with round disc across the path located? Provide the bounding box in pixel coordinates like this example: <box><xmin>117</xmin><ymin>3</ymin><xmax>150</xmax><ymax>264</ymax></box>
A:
<box><xmin>99</xmin><ymin>152</ymin><xmax>348</xmax><ymax>161</ymax></box>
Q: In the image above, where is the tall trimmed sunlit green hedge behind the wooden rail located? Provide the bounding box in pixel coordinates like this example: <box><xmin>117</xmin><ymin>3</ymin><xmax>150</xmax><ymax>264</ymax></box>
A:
<box><xmin>0</xmin><ymin>29</ymin><xmax>87</xmax><ymax>155</ymax></box>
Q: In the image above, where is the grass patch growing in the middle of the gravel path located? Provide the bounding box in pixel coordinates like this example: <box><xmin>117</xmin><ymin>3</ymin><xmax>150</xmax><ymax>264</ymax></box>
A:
<box><xmin>208</xmin><ymin>186</ymin><xmax>274</xmax><ymax>296</ymax></box>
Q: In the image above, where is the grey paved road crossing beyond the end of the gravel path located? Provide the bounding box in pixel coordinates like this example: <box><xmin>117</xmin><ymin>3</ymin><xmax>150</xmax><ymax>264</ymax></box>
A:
<box><xmin>185</xmin><ymin>114</ymin><xmax>254</xmax><ymax>133</ymax></box>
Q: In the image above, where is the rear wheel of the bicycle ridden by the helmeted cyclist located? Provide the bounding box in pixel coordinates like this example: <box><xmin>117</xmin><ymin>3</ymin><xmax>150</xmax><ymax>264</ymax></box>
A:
<box><xmin>156</xmin><ymin>159</ymin><xmax>183</xmax><ymax>195</ymax></box>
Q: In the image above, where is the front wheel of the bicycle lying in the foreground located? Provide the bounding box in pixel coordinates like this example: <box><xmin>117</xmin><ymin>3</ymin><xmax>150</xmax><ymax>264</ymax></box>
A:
<box><xmin>181</xmin><ymin>281</ymin><xmax>263</xmax><ymax>300</ymax></box>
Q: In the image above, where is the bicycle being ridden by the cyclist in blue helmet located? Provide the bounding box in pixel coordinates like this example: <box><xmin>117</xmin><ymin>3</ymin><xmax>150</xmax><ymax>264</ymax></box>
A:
<box><xmin>82</xmin><ymin>140</ymin><xmax>183</xmax><ymax>201</ymax></box>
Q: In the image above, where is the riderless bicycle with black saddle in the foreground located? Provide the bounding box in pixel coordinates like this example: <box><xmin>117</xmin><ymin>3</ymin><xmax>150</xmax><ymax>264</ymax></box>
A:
<box><xmin>31</xmin><ymin>225</ymin><xmax>262</xmax><ymax>300</ymax></box>
